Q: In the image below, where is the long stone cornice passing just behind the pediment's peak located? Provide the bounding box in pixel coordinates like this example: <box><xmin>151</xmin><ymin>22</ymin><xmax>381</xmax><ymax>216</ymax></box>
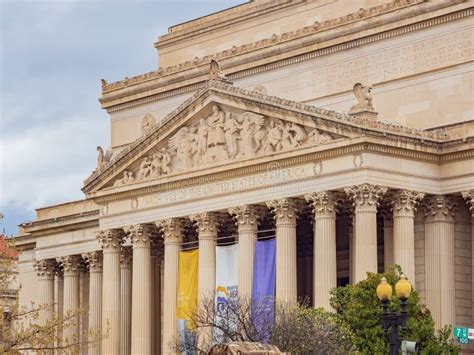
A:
<box><xmin>100</xmin><ymin>0</ymin><xmax>473</xmax><ymax>111</ymax></box>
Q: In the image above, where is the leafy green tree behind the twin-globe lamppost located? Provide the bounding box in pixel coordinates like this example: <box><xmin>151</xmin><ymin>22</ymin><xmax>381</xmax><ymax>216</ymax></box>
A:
<box><xmin>331</xmin><ymin>266</ymin><xmax>460</xmax><ymax>354</ymax></box>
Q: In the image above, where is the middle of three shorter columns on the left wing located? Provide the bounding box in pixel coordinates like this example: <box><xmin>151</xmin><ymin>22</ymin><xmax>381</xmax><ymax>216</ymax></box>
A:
<box><xmin>57</xmin><ymin>255</ymin><xmax>82</xmax><ymax>344</ymax></box>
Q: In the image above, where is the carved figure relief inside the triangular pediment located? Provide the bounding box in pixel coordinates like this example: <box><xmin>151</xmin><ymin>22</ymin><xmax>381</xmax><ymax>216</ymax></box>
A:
<box><xmin>113</xmin><ymin>104</ymin><xmax>334</xmax><ymax>186</ymax></box>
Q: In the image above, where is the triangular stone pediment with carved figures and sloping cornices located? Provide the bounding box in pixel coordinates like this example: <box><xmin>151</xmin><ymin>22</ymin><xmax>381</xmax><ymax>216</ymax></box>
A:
<box><xmin>83</xmin><ymin>81</ymin><xmax>382</xmax><ymax>193</ymax></box>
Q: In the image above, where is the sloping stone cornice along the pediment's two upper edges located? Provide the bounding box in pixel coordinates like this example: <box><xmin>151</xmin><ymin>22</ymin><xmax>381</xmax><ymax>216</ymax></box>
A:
<box><xmin>83</xmin><ymin>81</ymin><xmax>462</xmax><ymax>194</ymax></box>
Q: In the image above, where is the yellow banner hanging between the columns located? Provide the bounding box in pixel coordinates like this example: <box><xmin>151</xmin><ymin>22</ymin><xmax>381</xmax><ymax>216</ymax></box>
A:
<box><xmin>176</xmin><ymin>249</ymin><xmax>199</xmax><ymax>321</ymax></box>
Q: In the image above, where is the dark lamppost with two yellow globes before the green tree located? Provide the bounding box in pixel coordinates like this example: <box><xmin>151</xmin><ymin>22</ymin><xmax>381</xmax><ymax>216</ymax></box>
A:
<box><xmin>377</xmin><ymin>274</ymin><xmax>411</xmax><ymax>355</ymax></box>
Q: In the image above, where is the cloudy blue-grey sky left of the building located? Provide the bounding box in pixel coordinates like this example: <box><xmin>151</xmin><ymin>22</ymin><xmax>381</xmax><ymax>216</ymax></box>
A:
<box><xmin>0</xmin><ymin>0</ymin><xmax>245</xmax><ymax>235</ymax></box>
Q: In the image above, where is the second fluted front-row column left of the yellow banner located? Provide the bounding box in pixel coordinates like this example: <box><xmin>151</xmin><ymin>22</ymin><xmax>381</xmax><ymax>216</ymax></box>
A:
<box><xmin>126</xmin><ymin>224</ymin><xmax>156</xmax><ymax>355</ymax></box>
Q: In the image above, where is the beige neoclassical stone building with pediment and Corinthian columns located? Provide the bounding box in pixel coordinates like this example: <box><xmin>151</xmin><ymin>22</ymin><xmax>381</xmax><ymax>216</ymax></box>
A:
<box><xmin>18</xmin><ymin>0</ymin><xmax>474</xmax><ymax>354</ymax></box>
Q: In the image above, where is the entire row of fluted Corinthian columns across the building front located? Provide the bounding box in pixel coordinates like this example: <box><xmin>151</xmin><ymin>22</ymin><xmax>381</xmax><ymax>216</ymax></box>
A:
<box><xmin>36</xmin><ymin>188</ymin><xmax>474</xmax><ymax>355</ymax></box>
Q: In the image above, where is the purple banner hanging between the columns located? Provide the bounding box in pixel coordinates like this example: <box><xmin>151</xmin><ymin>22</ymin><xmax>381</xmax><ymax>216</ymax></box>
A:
<box><xmin>252</xmin><ymin>238</ymin><xmax>276</xmax><ymax>341</ymax></box>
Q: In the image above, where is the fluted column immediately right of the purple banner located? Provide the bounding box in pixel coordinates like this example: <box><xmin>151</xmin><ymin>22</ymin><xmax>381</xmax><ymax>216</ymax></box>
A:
<box><xmin>267</xmin><ymin>198</ymin><xmax>297</xmax><ymax>303</ymax></box>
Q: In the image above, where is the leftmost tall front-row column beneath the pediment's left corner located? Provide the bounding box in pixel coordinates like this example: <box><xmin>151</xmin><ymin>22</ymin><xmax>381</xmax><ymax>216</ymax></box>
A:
<box><xmin>97</xmin><ymin>229</ymin><xmax>124</xmax><ymax>355</ymax></box>
